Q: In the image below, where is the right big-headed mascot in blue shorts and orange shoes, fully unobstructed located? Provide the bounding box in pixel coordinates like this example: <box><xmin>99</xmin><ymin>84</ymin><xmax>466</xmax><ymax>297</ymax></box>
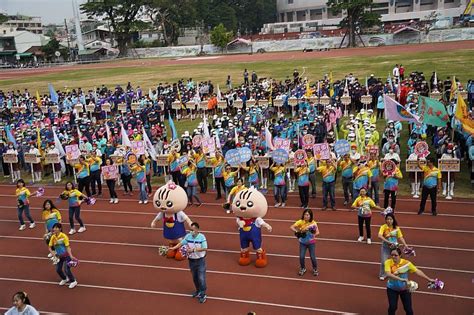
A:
<box><xmin>232</xmin><ymin>187</ymin><xmax>272</xmax><ymax>268</ymax></box>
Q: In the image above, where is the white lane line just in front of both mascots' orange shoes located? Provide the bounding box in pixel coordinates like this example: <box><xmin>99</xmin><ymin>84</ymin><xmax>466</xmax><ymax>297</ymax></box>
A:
<box><xmin>0</xmin><ymin>255</ymin><xmax>474</xmax><ymax>300</ymax></box>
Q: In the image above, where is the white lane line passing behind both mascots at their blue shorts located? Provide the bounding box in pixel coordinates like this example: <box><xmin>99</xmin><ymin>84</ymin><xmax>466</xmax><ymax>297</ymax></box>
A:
<box><xmin>0</xmin><ymin>219</ymin><xmax>474</xmax><ymax>252</ymax></box>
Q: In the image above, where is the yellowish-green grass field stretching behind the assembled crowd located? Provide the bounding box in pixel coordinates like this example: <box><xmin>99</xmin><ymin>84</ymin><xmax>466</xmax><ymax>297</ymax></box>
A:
<box><xmin>0</xmin><ymin>50</ymin><xmax>474</xmax><ymax>197</ymax></box>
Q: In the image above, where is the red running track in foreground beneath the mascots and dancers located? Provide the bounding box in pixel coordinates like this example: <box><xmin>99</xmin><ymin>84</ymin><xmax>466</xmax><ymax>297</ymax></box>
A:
<box><xmin>0</xmin><ymin>186</ymin><xmax>474</xmax><ymax>315</ymax></box>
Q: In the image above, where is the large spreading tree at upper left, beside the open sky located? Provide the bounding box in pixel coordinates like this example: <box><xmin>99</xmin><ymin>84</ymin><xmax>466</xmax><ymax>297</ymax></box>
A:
<box><xmin>81</xmin><ymin>0</ymin><xmax>151</xmax><ymax>56</ymax></box>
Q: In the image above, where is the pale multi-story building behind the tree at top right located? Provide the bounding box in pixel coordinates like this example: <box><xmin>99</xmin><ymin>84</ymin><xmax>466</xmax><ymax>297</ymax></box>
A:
<box><xmin>262</xmin><ymin>0</ymin><xmax>470</xmax><ymax>34</ymax></box>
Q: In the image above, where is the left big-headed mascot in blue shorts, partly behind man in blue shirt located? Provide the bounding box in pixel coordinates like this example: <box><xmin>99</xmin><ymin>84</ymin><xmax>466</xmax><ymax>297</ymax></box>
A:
<box><xmin>151</xmin><ymin>181</ymin><xmax>192</xmax><ymax>260</ymax></box>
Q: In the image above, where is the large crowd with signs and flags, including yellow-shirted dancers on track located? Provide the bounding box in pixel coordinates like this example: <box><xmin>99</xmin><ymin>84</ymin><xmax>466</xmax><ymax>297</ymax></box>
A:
<box><xmin>0</xmin><ymin>65</ymin><xmax>474</xmax><ymax>314</ymax></box>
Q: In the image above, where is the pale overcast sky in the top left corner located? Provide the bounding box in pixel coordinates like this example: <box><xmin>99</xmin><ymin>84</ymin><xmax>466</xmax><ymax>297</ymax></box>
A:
<box><xmin>0</xmin><ymin>0</ymin><xmax>87</xmax><ymax>24</ymax></box>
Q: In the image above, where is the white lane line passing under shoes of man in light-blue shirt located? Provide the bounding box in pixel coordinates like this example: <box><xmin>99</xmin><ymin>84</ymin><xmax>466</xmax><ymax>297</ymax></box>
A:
<box><xmin>0</xmin><ymin>278</ymin><xmax>354</xmax><ymax>314</ymax></box>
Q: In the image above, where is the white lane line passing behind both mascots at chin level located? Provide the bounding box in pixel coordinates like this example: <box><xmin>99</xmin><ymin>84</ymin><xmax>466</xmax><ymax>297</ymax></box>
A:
<box><xmin>0</xmin><ymin>206</ymin><xmax>474</xmax><ymax>234</ymax></box>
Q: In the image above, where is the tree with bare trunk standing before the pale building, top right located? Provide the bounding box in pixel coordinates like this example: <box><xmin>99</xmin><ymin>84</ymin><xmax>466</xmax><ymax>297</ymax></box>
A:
<box><xmin>327</xmin><ymin>0</ymin><xmax>381</xmax><ymax>47</ymax></box>
